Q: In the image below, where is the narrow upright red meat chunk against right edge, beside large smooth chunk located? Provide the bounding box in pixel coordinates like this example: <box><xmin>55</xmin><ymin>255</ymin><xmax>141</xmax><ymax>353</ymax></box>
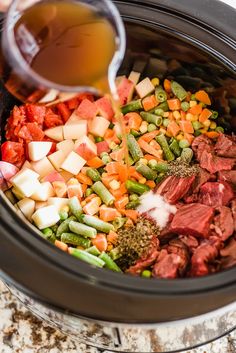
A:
<box><xmin>211</xmin><ymin>206</ymin><xmax>234</xmax><ymax>241</ymax></box>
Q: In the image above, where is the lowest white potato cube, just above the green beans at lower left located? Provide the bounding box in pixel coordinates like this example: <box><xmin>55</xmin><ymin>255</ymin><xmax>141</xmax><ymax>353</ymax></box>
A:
<box><xmin>32</xmin><ymin>206</ymin><xmax>60</xmax><ymax>229</ymax></box>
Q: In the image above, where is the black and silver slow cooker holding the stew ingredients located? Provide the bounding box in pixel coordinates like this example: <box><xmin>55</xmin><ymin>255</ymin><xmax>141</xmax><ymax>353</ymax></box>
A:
<box><xmin>0</xmin><ymin>0</ymin><xmax>236</xmax><ymax>352</ymax></box>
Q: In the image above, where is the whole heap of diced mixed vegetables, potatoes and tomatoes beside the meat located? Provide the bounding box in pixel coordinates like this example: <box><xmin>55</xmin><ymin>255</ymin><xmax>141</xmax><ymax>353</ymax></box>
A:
<box><xmin>0</xmin><ymin>72</ymin><xmax>234</xmax><ymax>277</ymax></box>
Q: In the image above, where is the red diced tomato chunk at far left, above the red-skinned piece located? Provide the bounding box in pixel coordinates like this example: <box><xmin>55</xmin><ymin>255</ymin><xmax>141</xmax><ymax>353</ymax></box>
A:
<box><xmin>1</xmin><ymin>141</ymin><xmax>25</xmax><ymax>168</ymax></box>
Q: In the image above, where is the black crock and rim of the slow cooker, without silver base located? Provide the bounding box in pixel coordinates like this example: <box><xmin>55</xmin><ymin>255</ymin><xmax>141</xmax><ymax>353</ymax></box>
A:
<box><xmin>0</xmin><ymin>0</ymin><xmax>236</xmax><ymax>323</ymax></box>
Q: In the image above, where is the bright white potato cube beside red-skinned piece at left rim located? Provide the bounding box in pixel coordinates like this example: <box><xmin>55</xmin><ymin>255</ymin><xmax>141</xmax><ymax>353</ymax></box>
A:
<box><xmin>11</xmin><ymin>169</ymin><xmax>40</xmax><ymax>197</ymax></box>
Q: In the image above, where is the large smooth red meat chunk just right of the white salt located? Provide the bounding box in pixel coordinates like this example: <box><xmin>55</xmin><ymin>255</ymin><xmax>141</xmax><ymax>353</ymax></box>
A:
<box><xmin>171</xmin><ymin>203</ymin><xmax>214</xmax><ymax>238</ymax></box>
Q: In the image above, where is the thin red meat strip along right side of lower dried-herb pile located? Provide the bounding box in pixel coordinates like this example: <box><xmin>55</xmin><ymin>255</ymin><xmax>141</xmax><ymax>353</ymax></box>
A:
<box><xmin>126</xmin><ymin>237</ymin><xmax>159</xmax><ymax>276</ymax></box>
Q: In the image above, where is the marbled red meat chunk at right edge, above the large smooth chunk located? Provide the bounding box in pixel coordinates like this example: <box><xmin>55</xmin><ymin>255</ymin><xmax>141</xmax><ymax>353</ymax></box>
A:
<box><xmin>199</xmin><ymin>181</ymin><xmax>234</xmax><ymax>207</ymax></box>
